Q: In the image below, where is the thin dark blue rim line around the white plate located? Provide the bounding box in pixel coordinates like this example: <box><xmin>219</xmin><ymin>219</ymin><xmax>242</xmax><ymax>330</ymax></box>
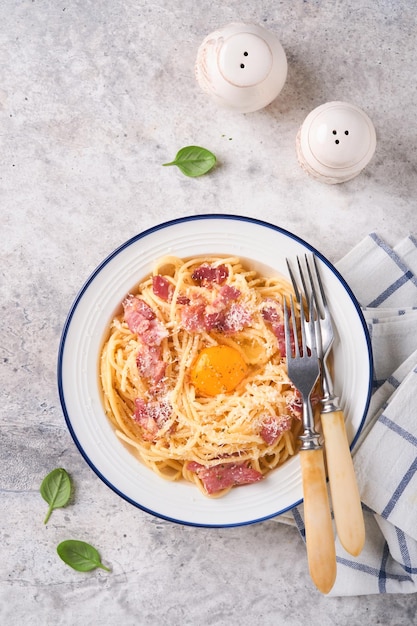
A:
<box><xmin>57</xmin><ymin>213</ymin><xmax>373</xmax><ymax>528</ymax></box>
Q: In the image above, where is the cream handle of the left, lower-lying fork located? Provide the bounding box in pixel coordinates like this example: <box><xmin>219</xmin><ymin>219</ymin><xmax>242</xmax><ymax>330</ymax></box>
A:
<box><xmin>300</xmin><ymin>449</ymin><xmax>336</xmax><ymax>593</ymax></box>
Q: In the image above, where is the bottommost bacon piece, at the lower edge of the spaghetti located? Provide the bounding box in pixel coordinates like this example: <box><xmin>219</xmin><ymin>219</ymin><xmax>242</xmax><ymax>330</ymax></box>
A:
<box><xmin>187</xmin><ymin>461</ymin><xmax>263</xmax><ymax>495</ymax></box>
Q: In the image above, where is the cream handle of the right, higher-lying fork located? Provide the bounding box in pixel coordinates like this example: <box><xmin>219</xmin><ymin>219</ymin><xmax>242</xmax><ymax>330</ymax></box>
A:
<box><xmin>321</xmin><ymin>410</ymin><xmax>365</xmax><ymax>556</ymax></box>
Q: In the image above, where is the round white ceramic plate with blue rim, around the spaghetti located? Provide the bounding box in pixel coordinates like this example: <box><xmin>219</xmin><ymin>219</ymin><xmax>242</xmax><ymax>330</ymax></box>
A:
<box><xmin>58</xmin><ymin>215</ymin><xmax>372</xmax><ymax>526</ymax></box>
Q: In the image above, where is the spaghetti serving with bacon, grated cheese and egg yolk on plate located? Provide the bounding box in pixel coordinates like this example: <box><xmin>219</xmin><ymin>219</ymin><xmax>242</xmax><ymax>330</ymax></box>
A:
<box><xmin>100</xmin><ymin>256</ymin><xmax>301</xmax><ymax>496</ymax></box>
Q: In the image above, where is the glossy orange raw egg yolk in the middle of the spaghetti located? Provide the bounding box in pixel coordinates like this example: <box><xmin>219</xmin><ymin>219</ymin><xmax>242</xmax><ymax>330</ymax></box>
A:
<box><xmin>191</xmin><ymin>346</ymin><xmax>248</xmax><ymax>396</ymax></box>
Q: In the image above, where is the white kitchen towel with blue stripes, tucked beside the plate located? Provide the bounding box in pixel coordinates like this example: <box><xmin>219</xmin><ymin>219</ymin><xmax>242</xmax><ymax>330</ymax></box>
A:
<box><xmin>293</xmin><ymin>233</ymin><xmax>417</xmax><ymax>596</ymax></box>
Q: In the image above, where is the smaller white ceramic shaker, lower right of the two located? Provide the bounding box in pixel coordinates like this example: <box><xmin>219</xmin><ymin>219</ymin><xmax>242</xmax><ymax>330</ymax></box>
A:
<box><xmin>296</xmin><ymin>101</ymin><xmax>376</xmax><ymax>184</ymax></box>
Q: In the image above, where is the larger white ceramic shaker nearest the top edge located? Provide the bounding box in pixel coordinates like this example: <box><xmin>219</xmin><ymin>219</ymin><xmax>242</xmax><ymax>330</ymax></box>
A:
<box><xmin>195</xmin><ymin>23</ymin><xmax>288</xmax><ymax>113</ymax></box>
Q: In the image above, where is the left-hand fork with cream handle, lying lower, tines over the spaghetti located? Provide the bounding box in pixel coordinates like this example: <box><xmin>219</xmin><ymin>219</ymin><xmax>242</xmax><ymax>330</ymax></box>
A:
<box><xmin>283</xmin><ymin>297</ymin><xmax>336</xmax><ymax>593</ymax></box>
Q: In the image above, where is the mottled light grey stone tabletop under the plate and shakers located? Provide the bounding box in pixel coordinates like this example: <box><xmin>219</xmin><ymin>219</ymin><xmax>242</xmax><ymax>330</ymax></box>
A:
<box><xmin>0</xmin><ymin>0</ymin><xmax>417</xmax><ymax>626</ymax></box>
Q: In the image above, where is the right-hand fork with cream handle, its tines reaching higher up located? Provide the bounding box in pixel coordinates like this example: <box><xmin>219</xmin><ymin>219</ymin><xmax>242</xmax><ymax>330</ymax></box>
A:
<box><xmin>287</xmin><ymin>255</ymin><xmax>365</xmax><ymax>556</ymax></box>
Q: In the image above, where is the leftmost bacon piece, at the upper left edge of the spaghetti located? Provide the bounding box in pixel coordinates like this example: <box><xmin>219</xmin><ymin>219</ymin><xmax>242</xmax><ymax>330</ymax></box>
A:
<box><xmin>123</xmin><ymin>296</ymin><xmax>168</xmax><ymax>346</ymax></box>
